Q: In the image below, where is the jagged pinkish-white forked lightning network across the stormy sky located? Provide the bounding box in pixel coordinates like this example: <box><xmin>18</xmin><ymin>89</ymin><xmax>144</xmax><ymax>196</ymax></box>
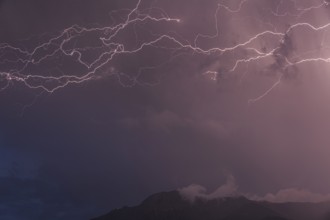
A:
<box><xmin>0</xmin><ymin>0</ymin><xmax>330</xmax><ymax>103</ymax></box>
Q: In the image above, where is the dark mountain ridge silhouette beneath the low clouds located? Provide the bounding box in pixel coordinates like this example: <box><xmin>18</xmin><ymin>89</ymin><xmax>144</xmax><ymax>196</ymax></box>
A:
<box><xmin>93</xmin><ymin>191</ymin><xmax>330</xmax><ymax>220</ymax></box>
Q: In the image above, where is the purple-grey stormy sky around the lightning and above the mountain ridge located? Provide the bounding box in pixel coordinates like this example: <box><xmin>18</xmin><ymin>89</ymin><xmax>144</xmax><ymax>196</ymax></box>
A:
<box><xmin>0</xmin><ymin>0</ymin><xmax>330</xmax><ymax>219</ymax></box>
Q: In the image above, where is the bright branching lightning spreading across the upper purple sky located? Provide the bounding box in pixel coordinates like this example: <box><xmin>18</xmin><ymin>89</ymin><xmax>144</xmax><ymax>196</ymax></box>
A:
<box><xmin>0</xmin><ymin>0</ymin><xmax>330</xmax><ymax>103</ymax></box>
